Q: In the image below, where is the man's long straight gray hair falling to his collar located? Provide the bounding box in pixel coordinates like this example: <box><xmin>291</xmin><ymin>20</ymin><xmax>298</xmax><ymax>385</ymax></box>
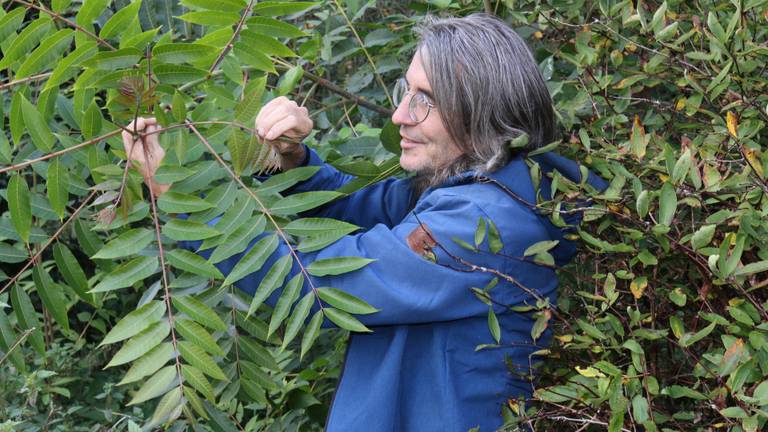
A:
<box><xmin>416</xmin><ymin>14</ymin><xmax>555</xmax><ymax>189</ymax></box>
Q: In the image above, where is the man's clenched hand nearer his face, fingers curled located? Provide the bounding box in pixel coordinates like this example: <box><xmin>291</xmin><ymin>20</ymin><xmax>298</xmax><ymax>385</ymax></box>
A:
<box><xmin>256</xmin><ymin>96</ymin><xmax>314</xmax><ymax>170</ymax></box>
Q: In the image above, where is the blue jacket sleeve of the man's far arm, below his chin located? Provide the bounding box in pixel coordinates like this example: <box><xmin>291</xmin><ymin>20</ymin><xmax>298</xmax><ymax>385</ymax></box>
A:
<box><xmin>272</xmin><ymin>148</ymin><xmax>411</xmax><ymax>229</ymax></box>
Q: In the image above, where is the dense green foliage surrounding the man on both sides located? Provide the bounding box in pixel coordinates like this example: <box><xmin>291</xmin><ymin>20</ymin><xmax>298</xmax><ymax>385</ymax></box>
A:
<box><xmin>0</xmin><ymin>0</ymin><xmax>768</xmax><ymax>431</ymax></box>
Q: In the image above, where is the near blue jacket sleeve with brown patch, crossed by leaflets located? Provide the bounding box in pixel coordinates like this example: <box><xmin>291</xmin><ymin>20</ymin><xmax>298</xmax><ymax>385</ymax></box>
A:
<box><xmin>195</xmin><ymin>189</ymin><xmax>556</xmax><ymax>326</ymax></box>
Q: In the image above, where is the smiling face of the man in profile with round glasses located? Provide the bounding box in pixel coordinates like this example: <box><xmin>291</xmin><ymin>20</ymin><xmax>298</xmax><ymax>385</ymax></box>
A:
<box><xmin>392</xmin><ymin>52</ymin><xmax>462</xmax><ymax>173</ymax></box>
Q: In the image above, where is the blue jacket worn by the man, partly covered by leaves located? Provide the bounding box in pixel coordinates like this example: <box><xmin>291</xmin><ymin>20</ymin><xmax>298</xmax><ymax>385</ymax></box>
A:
<box><xmin>187</xmin><ymin>148</ymin><xmax>600</xmax><ymax>432</ymax></box>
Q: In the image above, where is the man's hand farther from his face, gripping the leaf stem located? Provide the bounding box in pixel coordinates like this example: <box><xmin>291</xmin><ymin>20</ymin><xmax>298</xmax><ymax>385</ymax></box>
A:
<box><xmin>123</xmin><ymin>117</ymin><xmax>171</xmax><ymax>196</ymax></box>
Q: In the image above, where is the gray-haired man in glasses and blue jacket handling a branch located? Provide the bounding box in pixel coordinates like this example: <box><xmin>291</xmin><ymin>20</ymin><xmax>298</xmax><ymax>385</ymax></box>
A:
<box><xmin>125</xmin><ymin>15</ymin><xmax>608</xmax><ymax>431</ymax></box>
